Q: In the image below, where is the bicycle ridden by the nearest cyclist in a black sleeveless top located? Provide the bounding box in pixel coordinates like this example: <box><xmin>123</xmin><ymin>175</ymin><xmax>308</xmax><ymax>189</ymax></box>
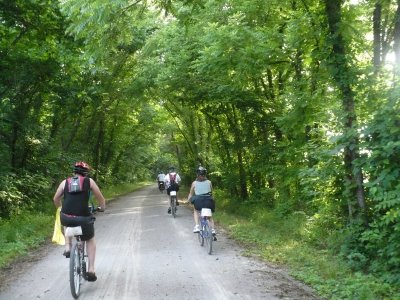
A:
<box><xmin>65</xmin><ymin>208</ymin><xmax>103</xmax><ymax>299</ymax></box>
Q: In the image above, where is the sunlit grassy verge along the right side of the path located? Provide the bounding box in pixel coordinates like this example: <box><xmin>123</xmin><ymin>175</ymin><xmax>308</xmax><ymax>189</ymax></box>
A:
<box><xmin>214</xmin><ymin>201</ymin><xmax>400</xmax><ymax>300</ymax></box>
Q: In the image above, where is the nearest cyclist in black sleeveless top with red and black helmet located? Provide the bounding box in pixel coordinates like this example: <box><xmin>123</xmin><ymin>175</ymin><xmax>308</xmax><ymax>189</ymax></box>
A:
<box><xmin>53</xmin><ymin>161</ymin><xmax>106</xmax><ymax>281</ymax></box>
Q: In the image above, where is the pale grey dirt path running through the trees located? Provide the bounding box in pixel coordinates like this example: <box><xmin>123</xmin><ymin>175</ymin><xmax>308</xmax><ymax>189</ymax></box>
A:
<box><xmin>0</xmin><ymin>186</ymin><xmax>318</xmax><ymax>300</ymax></box>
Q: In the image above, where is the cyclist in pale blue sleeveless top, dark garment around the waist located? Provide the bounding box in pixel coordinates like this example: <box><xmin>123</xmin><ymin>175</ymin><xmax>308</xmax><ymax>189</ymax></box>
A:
<box><xmin>188</xmin><ymin>166</ymin><xmax>215</xmax><ymax>235</ymax></box>
